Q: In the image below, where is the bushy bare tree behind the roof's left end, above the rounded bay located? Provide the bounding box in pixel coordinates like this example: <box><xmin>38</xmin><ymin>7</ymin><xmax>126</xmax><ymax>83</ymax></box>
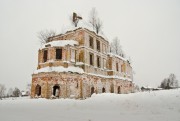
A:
<box><xmin>37</xmin><ymin>30</ymin><xmax>56</xmax><ymax>44</ymax></box>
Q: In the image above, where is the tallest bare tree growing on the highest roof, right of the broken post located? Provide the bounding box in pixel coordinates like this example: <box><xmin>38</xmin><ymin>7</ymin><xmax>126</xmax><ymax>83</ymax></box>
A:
<box><xmin>89</xmin><ymin>8</ymin><xmax>103</xmax><ymax>34</ymax></box>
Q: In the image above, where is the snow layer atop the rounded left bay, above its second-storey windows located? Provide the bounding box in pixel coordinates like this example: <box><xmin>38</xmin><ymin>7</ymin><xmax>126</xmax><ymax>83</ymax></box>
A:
<box><xmin>41</xmin><ymin>40</ymin><xmax>79</xmax><ymax>49</ymax></box>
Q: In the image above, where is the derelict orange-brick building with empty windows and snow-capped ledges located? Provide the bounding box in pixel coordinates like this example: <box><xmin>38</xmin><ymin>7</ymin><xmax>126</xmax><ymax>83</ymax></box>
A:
<box><xmin>31</xmin><ymin>27</ymin><xmax>134</xmax><ymax>99</ymax></box>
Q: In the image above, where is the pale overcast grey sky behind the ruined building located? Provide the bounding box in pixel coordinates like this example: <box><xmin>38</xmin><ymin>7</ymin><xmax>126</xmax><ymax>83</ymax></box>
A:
<box><xmin>0</xmin><ymin>0</ymin><xmax>180</xmax><ymax>89</ymax></box>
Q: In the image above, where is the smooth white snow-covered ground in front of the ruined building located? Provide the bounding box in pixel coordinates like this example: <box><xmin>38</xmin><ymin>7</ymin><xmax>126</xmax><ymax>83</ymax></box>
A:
<box><xmin>0</xmin><ymin>89</ymin><xmax>180</xmax><ymax>121</ymax></box>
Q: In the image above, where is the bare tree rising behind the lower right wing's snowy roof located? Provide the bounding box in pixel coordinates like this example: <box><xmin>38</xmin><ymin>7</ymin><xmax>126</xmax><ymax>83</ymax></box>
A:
<box><xmin>111</xmin><ymin>37</ymin><xmax>125</xmax><ymax>57</ymax></box>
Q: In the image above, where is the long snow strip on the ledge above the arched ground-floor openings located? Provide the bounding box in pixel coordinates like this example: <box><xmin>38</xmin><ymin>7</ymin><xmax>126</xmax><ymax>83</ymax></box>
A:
<box><xmin>34</xmin><ymin>66</ymin><xmax>84</xmax><ymax>74</ymax></box>
